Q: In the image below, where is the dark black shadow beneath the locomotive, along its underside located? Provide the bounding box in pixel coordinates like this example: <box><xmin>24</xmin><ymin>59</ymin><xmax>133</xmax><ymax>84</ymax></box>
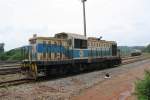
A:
<box><xmin>31</xmin><ymin>59</ymin><xmax>118</xmax><ymax>82</ymax></box>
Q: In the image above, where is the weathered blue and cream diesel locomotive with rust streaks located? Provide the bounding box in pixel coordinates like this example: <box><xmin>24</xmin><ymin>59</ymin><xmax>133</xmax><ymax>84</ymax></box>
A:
<box><xmin>22</xmin><ymin>32</ymin><xmax>121</xmax><ymax>79</ymax></box>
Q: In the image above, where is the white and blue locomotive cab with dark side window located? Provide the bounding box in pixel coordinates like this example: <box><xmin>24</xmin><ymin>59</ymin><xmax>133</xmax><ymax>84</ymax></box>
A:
<box><xmin>55</xmin><ymin>32</ymin><xmax>88</xmax><ymax>59</ymax></box>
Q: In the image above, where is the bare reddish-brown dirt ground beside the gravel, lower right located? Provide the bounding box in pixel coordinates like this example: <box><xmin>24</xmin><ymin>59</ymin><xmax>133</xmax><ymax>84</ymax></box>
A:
<box><xmin>72</xmin><ymin>63</ymin><xmax>150</xmax><ymax>100</ymax></box>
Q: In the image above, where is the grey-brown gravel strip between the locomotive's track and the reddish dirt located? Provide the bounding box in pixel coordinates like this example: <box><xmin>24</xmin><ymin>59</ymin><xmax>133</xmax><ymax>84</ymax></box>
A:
<box><xmin>0</xmin><ymin>60</ymin><xmax>150</xmax><ymax>100</ymax></box>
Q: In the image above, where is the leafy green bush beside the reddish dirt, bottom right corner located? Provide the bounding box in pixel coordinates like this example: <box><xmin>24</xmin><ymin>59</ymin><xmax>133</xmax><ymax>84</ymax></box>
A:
<box><xmin>135</xmin><ymin>71</ymin><xmax>150</xmax><ymax>100</ymax></box>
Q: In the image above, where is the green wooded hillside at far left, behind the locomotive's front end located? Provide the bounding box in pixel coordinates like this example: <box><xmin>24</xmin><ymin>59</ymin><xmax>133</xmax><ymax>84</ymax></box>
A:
<box><xmin>0</xmin><ymin>48</ymin><xmax>22</xmax><ymax>60</ymax></box>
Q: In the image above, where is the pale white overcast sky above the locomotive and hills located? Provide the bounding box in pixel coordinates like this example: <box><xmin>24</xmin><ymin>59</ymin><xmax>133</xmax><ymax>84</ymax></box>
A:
<box><xmin>0</xmin><ymin>0</ymin><xmax>150</xmax><ymax>50</ymax></box>
